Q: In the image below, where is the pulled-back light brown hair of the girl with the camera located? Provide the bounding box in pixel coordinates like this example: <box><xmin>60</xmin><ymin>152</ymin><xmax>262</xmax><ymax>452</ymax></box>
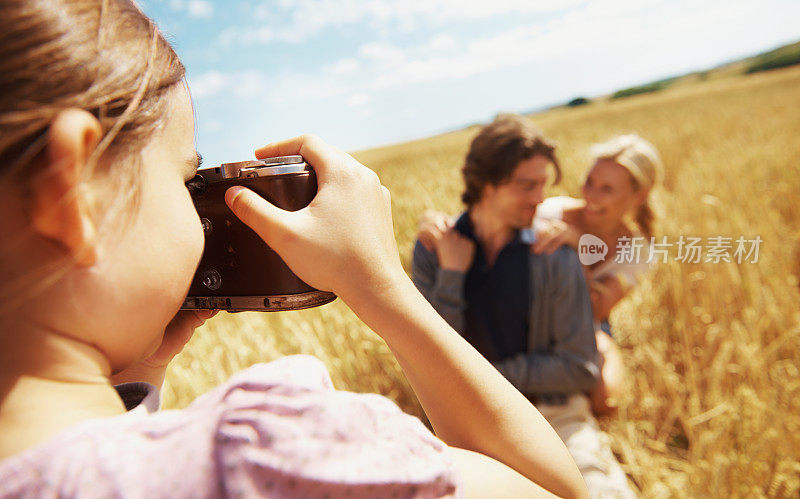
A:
<box><xmin>0</xmin><ymin>0</ymin><xmax>185</xmax><ymax>309</ymax></box>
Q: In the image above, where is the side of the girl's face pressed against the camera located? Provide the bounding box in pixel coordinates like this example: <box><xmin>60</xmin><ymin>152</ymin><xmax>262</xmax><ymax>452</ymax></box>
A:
<box><xmin>77</xmin><ymin>85</ymin><xmax>203</xmax><ymax>370</ymax></box>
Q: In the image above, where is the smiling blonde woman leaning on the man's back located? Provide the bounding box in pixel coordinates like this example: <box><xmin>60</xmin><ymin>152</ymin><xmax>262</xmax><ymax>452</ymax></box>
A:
<box><xmin>419</xmin><ymin>135</ymin><xmax>662</xmax><ymax>414</ymax></box>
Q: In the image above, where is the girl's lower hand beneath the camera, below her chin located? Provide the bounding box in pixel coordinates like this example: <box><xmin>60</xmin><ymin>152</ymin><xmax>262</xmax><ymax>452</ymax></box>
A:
<box><xmin>110</xmin><ymin>310</ymin><xmax>218</xmax><ymax>388</ymax></box>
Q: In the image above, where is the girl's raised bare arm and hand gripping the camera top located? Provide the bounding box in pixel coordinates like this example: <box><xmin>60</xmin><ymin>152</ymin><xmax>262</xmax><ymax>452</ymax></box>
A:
<box><xmin>226</xmin><ymin>136</ymin><xmax>587</xmax><ymax>497</ymax></box>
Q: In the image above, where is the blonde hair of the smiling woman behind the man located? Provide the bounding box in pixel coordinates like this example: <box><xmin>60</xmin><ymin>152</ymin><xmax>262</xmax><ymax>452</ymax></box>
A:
<box><xmin>591</xmin><ymin>134</ymin><xmax>664</xmax><ymax>239</ymax></box>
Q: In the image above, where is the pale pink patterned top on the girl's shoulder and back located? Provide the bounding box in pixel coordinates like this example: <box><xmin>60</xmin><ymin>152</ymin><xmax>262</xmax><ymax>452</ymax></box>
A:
<box><xmin>0</xmin><ymin>356</ymin><xmax>458</xmax><ymax>497</ymax></box>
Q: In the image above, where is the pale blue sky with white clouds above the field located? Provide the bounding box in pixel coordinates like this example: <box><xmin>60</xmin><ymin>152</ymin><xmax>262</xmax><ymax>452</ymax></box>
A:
<box><xmin>139</xmin><ymin>0</ymin><xmax>800</xmax><ymax>166</ymax></box>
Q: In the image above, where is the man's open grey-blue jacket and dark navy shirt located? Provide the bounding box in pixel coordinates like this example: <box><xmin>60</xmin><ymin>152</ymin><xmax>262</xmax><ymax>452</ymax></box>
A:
<box><xmin>412</xmin><ymin>214</ymin><xmax>600</xmax><ymax>402</ymax></box>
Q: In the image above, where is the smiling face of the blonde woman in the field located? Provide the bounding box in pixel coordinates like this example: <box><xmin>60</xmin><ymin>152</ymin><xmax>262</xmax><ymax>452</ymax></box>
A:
<box><xmin>582</xmin><ymin>159</ymin><xmax>641</xmax><ymax>230</ymax></box>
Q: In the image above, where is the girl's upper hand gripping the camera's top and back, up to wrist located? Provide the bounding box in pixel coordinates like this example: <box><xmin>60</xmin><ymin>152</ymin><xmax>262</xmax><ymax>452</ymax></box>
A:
<box><xmin>225</xmin><ymin>135</ymin><xmax>408</xmax><ymax>306</ymax></box>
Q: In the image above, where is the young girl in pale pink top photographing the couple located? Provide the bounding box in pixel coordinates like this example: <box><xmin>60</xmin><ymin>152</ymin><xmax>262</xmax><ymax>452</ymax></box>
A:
<box><xmin>0</xmin><ymin>0</ymin><xmax>586</xmax><ymax>497</ymax></box>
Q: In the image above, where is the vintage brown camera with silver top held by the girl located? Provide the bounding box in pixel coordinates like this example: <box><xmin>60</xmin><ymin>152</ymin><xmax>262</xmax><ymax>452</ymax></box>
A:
<box><xmin>181</xmin><ymin>156</ymin><xmax>336</xmax><ymax>312</ymax></box>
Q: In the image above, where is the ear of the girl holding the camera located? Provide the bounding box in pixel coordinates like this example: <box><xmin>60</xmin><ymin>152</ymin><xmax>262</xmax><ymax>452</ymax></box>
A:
<box><xmin>29</xmin><ymin>109</ymin><xmax>102</xmax><ymax>267</ymax></box>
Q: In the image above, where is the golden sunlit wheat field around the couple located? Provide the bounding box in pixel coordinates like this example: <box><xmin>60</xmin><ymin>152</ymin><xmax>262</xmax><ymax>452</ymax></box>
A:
<box><xmin>164</xmin><ymin>67</ymin><xmax>800</xmax><ymax>497</ymax></box>
